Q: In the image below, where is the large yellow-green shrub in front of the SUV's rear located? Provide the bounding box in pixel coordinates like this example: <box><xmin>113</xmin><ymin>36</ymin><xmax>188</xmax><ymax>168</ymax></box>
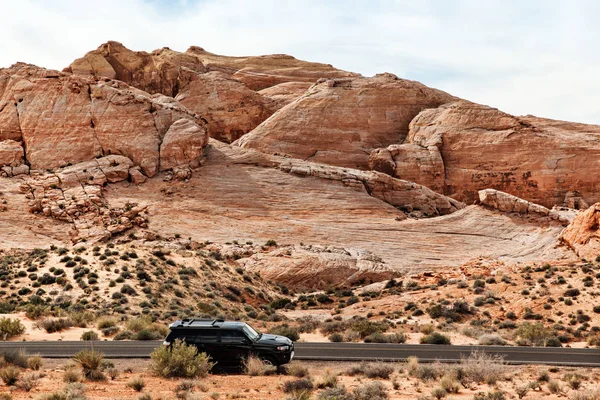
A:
<box><xmin>150</xmin><ymin>339</ymin><xmax>214</xmax><ymax>378</ymax></box>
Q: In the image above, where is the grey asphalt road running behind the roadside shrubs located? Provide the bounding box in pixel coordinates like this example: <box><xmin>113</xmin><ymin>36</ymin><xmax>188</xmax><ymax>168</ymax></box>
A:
<box><xmin>0</xmin><ymin>341</ymin><xmax>600</xmax><ymax>367</ymax></box>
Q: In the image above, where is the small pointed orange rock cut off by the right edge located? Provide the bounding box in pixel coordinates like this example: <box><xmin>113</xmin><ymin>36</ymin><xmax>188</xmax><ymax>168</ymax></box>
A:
<box><xmin>559</xmin><ymin>203</ymin><xmax>600</xmax><ymax>261</ymax></box>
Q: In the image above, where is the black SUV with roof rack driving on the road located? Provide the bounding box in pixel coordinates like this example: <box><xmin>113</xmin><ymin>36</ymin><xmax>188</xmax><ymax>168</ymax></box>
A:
<box><xmin>164</xmin><ymin>319</ymin><xmax>294</xmax><ymax>366</ymax></box>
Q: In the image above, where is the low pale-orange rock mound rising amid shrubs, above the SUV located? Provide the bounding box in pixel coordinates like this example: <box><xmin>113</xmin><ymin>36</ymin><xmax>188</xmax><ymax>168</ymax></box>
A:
<box><xmin>238</xmin><ymin>246</ymin><xmax>397</xmax><ymax>290</ymax></box>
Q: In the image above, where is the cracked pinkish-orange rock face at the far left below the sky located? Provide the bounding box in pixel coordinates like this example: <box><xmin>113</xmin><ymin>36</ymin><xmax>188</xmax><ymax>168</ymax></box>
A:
<box><xmin>0</xmin><ymin>64</ymin><xmax>204</xmax><ymax>176</ymax></box>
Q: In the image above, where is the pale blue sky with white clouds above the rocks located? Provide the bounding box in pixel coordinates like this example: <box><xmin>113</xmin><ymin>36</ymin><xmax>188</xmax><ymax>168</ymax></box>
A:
<box><xmin>0</xmin><ymin>0</ymin><xmax>600</xmax><ymax>124</ymax></box>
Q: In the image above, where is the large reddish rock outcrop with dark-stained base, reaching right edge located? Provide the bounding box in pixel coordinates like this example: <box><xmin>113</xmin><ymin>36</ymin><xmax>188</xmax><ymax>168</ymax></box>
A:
<box><xmin>370</xmin><ymin>101</ymin><xmax>600</xmax><ymax>207</ymax></box>
